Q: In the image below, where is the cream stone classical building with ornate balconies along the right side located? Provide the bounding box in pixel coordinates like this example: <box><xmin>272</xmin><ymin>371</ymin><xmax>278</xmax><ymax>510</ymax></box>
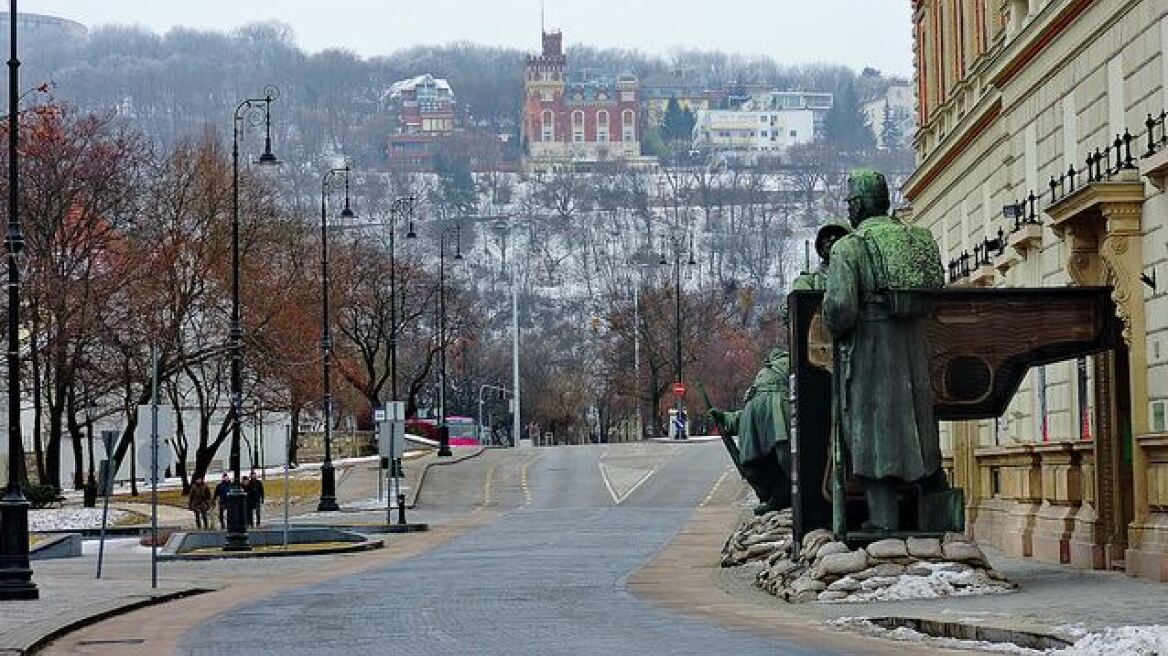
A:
<box><xmin>903</xmin><ymin>0</ymin><xmax>1168</xmax><ymax>580</ymax></box>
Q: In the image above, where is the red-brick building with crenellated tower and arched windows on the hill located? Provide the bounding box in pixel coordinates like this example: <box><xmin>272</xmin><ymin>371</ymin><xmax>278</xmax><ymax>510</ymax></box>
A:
<box><xmin>522</xmin><ymin>30</ymin><xmax>641</xmax><ymax>161</ymax></box>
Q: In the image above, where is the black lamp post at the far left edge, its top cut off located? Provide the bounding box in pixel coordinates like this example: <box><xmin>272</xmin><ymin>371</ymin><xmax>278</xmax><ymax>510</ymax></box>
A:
<box><xmin>0</xmin><ymin>0</ymin><xmax>40</xmax><ymax>600</ymax></box>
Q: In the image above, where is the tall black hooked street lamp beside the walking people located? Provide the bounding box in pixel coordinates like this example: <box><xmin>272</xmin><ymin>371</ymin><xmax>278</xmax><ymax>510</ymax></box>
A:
<box><xmin>223</xmin><ymin>86</ymin><xmax>279</xmax><ymax>551</ymax></box>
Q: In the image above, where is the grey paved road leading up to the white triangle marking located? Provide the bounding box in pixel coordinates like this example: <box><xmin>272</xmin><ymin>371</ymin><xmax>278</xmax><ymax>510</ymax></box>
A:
<box><xmin>179</xmin><ymin>442</ymin><xmax>845</xmax><ymax>656</ymax></box>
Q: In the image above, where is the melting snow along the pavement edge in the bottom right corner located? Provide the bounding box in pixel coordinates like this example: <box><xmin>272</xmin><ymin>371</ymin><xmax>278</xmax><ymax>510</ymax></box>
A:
<box><xmin>827</xmin><ymin>617</ymin><xmax>1168</xmax><ymax>656</ymax></box>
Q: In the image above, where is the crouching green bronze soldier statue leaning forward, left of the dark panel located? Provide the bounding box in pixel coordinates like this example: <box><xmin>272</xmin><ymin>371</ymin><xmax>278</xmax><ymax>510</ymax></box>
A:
<box><xmin>707</xmin><ymin>348</ymin><xmax>791</xmax><ymax>515</ymax></box>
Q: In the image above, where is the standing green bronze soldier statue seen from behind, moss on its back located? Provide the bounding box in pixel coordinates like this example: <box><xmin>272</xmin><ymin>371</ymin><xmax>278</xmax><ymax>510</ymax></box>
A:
<box><xmin>823</xmin><ymin>169</ymin><xmax>946</xmax><ymax>531</ymax></box>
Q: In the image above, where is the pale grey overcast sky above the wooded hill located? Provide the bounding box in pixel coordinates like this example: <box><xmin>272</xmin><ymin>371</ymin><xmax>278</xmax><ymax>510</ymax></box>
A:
<box><xmin>20</xmin><ymin>0</ymin><xmax>912</xmax><ymax>75</ymax></box>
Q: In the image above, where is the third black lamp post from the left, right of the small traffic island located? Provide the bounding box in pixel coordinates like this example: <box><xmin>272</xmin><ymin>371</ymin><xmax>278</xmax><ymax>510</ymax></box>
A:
<box><xmin>317</xmin><ymin>165</ymin><xmax>356</xmax><ymax>512</ymax></box>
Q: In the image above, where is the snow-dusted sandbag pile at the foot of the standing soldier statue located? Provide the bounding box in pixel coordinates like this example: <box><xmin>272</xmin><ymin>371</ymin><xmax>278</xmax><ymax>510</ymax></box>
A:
<box><xmin>755</xmin><ymin>529</ymin><xmax>1017</xmax><ymax>603</ymax></box>
